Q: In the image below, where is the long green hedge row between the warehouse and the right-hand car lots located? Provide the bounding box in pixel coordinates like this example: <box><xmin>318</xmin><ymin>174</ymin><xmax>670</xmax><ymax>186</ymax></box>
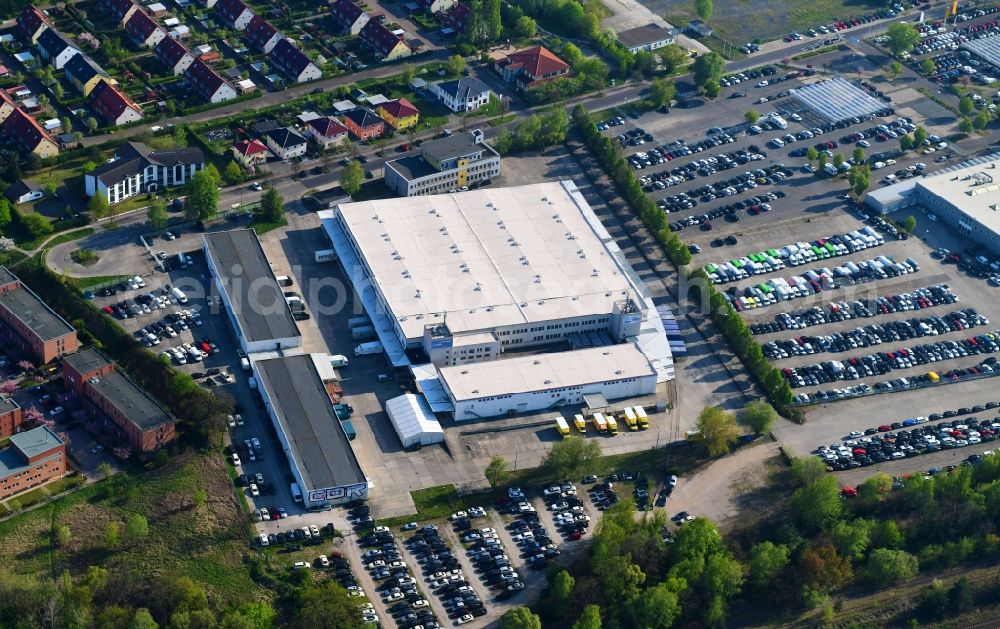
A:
<box><xmin>573</xmin><ymin>105</ymin><xmax>794</xmax><ymax>415</ymax></box>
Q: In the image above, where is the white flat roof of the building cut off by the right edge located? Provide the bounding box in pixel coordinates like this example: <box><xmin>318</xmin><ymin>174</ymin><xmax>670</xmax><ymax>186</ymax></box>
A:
<box><xmin>917</xmin><ymin>154</ymin><xmax>1000</xmax><ymax>234</ymax></box>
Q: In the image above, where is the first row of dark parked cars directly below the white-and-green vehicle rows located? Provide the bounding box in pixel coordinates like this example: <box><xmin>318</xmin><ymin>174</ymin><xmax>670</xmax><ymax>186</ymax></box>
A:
<box><xmin>749</xmin><ymin>284</ymin><xmax>958</xmax><ymax>334</ymax></box>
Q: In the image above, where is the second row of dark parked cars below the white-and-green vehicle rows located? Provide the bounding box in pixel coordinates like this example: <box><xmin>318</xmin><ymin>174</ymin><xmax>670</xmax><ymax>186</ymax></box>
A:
<box><xmin>761</xmin><ymin>308</ymin><xmax>989</xmax><ymax>360</ymax></box>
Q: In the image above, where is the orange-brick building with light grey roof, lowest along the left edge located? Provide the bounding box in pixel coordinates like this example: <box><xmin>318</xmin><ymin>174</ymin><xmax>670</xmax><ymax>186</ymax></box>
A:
<box><xmin>0</xmin><ymin>426</ymin><xmax>68</xmax><ymax>500</ymax></box>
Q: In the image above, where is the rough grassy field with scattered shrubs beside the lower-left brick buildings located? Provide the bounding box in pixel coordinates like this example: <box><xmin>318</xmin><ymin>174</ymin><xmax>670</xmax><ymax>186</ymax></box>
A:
<box><xmin>0</xmin><ymin>455</ymin><xmax>268</xmax><ymax>603</ymax></box>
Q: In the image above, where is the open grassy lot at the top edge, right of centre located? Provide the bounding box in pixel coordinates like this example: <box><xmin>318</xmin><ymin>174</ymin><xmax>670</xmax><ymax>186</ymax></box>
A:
<box><xmin>660</xmin><ymin>0</ymin><xmax>886</xmax><ymax>46</ymax></box>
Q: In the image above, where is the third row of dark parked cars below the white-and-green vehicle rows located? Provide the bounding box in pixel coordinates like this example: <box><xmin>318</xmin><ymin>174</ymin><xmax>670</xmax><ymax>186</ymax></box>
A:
<box><xmin>781</xmin><ymin>332</ymin><xmax>1000</xmax><ymax>388</ymax></box>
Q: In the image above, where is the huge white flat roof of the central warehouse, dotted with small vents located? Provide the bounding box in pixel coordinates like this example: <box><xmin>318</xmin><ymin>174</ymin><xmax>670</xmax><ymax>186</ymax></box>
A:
<box><xmin>337</xmin><ymin>181</ymin><xmax>635</xmax><ymax>339</ymax></box>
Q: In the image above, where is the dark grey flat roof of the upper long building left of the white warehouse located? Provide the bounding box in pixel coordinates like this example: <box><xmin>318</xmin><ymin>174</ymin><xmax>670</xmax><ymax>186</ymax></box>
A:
<box><xmin>205</xmin><ymin>229</ymin><xmax>301</xmax><ymax>342</ymax></box>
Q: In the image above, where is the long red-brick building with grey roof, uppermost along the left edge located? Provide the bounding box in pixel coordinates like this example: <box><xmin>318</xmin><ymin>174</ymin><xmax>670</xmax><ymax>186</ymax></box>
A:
<box><xmin>0</xmin><ymin>267</ymin><xmax>80</xmax><ymax>365</ymax></box>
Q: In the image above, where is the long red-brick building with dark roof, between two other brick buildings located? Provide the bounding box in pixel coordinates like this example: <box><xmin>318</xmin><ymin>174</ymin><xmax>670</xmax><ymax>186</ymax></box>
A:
<box><xmin>62</xmin><ymin>348</ymin><xmax>177</xmax><ymax>456</ymax></box>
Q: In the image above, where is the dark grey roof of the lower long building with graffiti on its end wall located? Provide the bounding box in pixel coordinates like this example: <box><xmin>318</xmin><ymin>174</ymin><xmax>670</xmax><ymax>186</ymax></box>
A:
<box><xmin>254</xmin><ymin>354</ymin><xmax>366</xmax><ymax>491</ymax></box>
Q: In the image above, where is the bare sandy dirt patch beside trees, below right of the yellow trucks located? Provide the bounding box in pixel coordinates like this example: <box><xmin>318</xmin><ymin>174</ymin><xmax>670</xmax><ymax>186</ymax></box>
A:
<box><xmin>667</xmin><ymin>441</ymin><xmax>778</xmax><ymax>530</ymax></box>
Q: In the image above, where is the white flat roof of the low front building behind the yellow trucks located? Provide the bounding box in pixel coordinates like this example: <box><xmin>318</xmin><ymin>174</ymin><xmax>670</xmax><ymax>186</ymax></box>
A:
<box><xmin>439</xmin><ymin>343</ymin><xmax>656</xmax><ymax>402</ymax></box>
